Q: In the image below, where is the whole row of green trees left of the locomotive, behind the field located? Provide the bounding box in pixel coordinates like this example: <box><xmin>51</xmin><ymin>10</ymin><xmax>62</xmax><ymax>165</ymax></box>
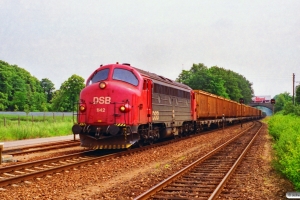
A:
<box><xmin>0</xmin><ymin>60</ymin><xmax>84</xmax><ymax>113</ymax></box>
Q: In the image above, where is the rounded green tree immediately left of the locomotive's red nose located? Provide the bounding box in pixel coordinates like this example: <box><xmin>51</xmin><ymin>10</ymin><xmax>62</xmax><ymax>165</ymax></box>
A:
<box><xmin>51</xmin><ymin>75</ymin><xmax>85</xmax><ymax>111</ymax></box>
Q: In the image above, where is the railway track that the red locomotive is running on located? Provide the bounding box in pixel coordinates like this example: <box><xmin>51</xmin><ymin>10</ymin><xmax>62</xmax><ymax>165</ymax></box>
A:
<box><xmin>0</xmin><ymin>122</ymin><xmax>255</xmax><ymax>190</ymax></box>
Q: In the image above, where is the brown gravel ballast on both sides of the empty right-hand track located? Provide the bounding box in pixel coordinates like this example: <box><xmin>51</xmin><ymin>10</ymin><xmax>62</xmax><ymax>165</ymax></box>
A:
<box><xmin>0</xmin><ymin>123</ymin><xmax>293</xmax><ymax>200</ymax></box>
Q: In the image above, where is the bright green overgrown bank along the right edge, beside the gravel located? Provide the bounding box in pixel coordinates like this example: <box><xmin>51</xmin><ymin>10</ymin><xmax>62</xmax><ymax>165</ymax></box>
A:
<box><xmin>267</xmin><ymin>114</ymin><xmax>300</xmax><ymax>191</ymax></box>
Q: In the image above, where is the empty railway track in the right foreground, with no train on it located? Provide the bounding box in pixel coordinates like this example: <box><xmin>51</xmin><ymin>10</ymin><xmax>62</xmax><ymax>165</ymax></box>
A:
<box><xmin>135</xmin><ymin>122</ymin><xmax>262</xmax><ymax>200</ymax></box>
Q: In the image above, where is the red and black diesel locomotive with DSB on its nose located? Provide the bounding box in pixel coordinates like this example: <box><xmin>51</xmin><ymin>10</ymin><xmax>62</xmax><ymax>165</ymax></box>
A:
<box><xmin>72</xmin><ymin>63</ymin><xmax>258</xmax><ymax>149</ymax></box>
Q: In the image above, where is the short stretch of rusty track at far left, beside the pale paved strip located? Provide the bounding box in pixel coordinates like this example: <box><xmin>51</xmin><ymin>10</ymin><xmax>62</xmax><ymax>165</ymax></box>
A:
<box><xmin>2</xmin><ymin>140</ymin><xmax>80</xmax><ymax>156</ymax></box>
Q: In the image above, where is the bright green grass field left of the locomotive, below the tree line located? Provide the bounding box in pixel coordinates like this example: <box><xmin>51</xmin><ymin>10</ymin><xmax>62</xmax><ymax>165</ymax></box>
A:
<box><xmin>0</xmin><ymin>115</ymin><xmax>73</xmax><ymax>142</ymax></box>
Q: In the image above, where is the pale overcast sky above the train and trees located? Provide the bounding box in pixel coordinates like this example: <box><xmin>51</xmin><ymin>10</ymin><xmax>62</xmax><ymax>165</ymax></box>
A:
<box><xmin>0</xmin><ymin>0</ymin><xmax>300</xmax><ymax>97</ymax></box>
